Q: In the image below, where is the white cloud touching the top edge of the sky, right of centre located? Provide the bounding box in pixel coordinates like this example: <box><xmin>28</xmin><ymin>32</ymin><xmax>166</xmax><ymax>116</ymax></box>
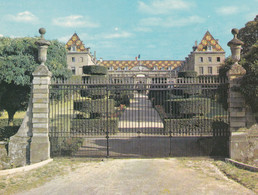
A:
<box><xmin>138</xmin><ymin>0</ymin><xmax>193</xmax><ymax>15</ymax></box>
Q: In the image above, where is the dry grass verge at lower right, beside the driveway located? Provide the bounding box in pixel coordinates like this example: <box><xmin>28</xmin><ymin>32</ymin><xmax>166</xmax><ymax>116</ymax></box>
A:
<box><xmin>214</xmin><ymin>161</ymin><xmax>258</xmax><ymax>194</ymax></box>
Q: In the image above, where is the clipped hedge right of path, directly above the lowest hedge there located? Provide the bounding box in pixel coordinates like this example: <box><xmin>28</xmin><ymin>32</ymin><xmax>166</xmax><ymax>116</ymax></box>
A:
<box><xmin>164</xmin><ymin>97</ymin><xmax>211</xmax><ymax>117</ymax></box>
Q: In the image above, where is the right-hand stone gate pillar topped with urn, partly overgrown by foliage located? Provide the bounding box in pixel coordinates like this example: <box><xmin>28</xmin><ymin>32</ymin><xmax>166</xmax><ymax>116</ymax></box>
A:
<box><xmin>227</xmin><ymin>29</ymin><xmax>247</xmax><ymax>160</ymax></box>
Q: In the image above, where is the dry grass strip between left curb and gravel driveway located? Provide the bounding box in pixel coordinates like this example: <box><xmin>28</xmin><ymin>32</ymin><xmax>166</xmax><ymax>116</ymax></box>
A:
<box><xmin>0</xmin><ymin>158</ymin><xmax>100</xmax><ymax>195</ymax></box>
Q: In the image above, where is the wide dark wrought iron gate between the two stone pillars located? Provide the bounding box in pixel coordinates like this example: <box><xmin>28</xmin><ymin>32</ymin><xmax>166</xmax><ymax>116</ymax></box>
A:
<box><xmin>49</xmin><ymin>77</ymin><xmax>229</xmax><ymax>157</ymax></box>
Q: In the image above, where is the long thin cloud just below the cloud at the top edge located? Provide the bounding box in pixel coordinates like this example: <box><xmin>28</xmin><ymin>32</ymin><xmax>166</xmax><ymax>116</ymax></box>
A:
<box><xmin>140</xmin><ymin>16</ymin><xmax>205</xmax><ymax>27</ymax></box>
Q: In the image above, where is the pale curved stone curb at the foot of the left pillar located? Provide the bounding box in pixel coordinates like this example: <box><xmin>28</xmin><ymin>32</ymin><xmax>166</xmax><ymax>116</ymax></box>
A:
<box><xmin>0</xmin><ymin>159</ymin><xmax>53</xmax><ymax>176</ymax></box>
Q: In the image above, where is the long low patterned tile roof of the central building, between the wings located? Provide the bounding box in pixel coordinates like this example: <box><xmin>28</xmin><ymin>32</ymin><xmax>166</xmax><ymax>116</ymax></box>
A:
<box><xmin>98</xmin><ymin>60</ymin><xmax>183</xmax><ymax>70</ymax></box>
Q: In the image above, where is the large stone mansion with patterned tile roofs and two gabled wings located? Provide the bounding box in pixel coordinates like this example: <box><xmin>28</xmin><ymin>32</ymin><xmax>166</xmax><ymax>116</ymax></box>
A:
<box><xmin>66</xmin><ymin>31</ymin><xmax>225</xmax><ymax>77</ymax></box>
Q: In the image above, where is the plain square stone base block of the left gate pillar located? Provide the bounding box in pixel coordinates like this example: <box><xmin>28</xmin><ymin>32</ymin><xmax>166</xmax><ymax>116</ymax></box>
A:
<box><xmin>30</xmin><ymin>136</ymin><xmax>50</xmax><ymax>164</ymax></box>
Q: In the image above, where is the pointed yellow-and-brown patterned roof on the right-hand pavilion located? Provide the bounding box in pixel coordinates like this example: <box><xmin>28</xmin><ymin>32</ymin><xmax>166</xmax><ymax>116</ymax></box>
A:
<box><xmin>196</xmin><ymin>31</ymin><xmax>224</xmax><ymax>52</ymax></box>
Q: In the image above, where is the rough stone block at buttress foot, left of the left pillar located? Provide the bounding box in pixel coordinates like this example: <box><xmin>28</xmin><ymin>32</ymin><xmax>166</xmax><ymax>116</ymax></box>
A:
<box><xmin>8</xmin><ymin>135</ymin><xmax>30</xmax><ymax>167</ymax></box>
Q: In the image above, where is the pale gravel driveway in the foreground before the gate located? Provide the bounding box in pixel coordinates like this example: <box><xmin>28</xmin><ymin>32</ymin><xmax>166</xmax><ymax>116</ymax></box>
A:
<box><xmin>19</xmin><ymin>159</ymin><xmax>254</xmax><ymax>195</ymax></box>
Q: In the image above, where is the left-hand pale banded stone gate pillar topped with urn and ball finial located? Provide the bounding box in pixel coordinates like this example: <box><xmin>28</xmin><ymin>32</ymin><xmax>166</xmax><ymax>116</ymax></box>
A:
<box><xmin>30</xmin><ymin>28</ymin><xmax>52</xmax><ymax>163</ymax></box>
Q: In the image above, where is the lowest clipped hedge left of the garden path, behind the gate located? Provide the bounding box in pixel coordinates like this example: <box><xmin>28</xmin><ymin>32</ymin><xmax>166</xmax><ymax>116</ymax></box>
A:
<box><xmin>71</xmin><ymin>118</ymin><xmax>118</xmax><ymax>135</ymax></box>
